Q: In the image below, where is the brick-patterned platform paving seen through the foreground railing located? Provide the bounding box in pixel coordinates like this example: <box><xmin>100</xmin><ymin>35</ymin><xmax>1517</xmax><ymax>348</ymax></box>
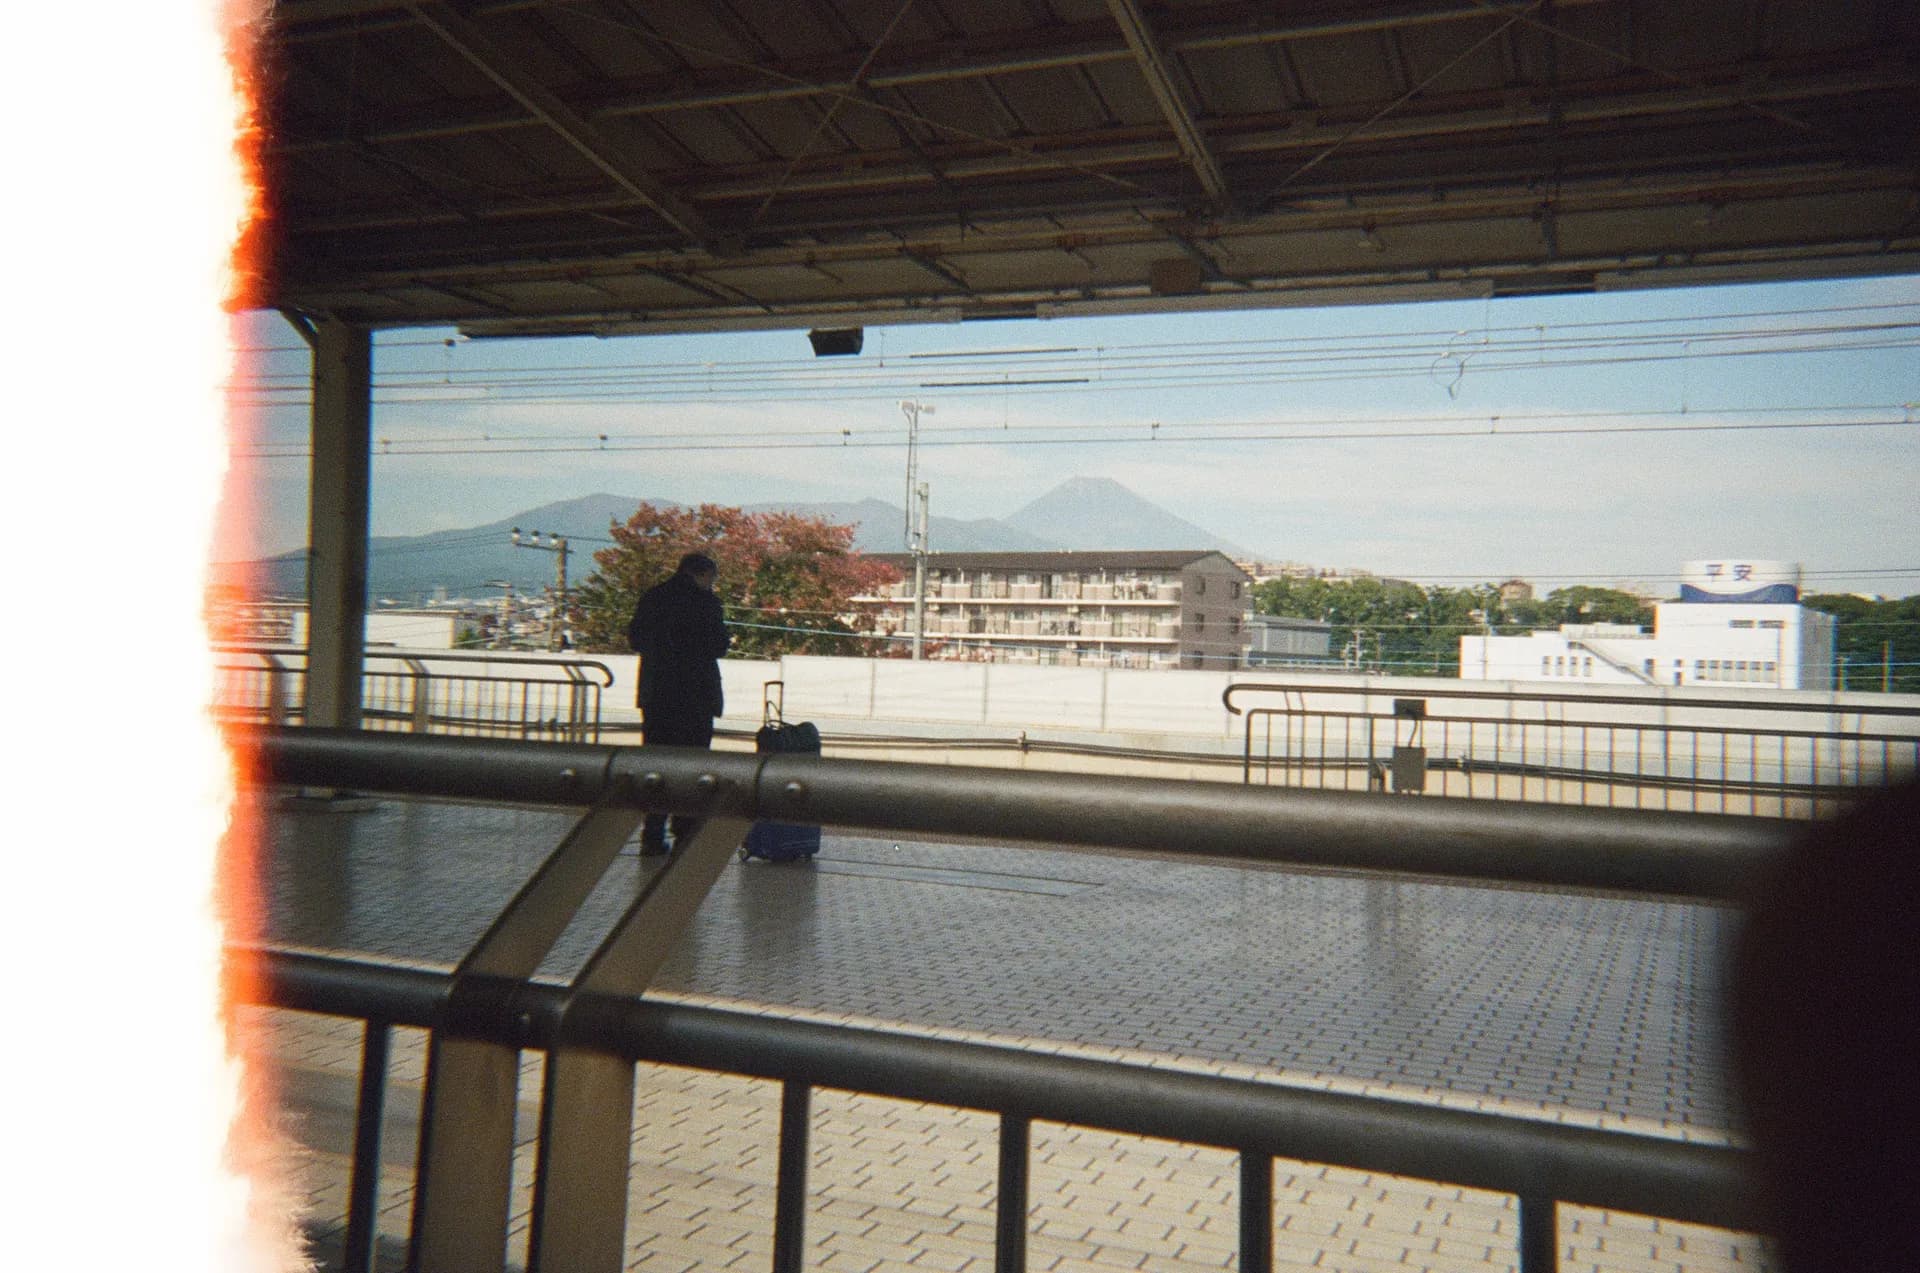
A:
<box><xmin>236</xmin><ymin>801</ymin><xmax>1766</xmax><ymax>1273</ymax></box>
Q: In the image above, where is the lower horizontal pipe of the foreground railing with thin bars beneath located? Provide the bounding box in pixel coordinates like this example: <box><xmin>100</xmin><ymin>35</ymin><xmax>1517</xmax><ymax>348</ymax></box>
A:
<box><xmin>230</xmin><ymin>949</ymin><xmax>1761</xmax><ymax>1273</ymax></box>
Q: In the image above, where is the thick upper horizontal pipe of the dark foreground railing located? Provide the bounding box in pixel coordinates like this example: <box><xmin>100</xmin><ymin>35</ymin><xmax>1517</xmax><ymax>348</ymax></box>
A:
<box><xmin>230</xmin><ymin>728</ymin><xmax>1789</xmax><ymax>901</ymax></box>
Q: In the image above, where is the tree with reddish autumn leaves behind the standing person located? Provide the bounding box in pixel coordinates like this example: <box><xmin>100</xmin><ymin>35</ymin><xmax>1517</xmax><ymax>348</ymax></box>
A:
<box><xmin>570</xmin><ymin>503</ymin><xmax>899</xmax><ymax>659</ymax></box>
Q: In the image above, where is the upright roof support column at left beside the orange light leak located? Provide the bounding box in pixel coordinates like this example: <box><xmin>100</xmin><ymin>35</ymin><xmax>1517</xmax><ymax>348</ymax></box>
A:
<box><xmin>307</xmin><ymin>319</ymin><xmax>372</xmax><ymax>730</ymax></box>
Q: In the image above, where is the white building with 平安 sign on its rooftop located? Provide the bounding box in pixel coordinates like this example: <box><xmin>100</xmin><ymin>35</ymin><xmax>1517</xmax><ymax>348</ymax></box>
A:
<box><xmin>1459</xmin><ymin>561</ymin><xmax>1836</xmax><ymax>689</ymax></box>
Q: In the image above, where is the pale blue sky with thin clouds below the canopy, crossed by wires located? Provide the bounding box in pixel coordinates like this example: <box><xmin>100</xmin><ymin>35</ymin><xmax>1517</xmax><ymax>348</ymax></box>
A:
<box><xmin>230</xmin><ymin>276</ymin><xmax>1920</xmax><ymax>595</ymax></box>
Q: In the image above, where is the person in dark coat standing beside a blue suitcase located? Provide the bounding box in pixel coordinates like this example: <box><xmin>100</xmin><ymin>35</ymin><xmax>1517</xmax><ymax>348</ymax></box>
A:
<box><xmin>626</xmin><ymin>553</ymin><xmax>732</xmax><ymax>856</ymax></box>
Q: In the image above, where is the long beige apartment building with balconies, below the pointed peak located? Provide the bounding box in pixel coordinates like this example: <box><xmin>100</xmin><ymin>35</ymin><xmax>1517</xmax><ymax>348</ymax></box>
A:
<box><xmin>852</xmin><ymin>551</ymin><xmax>1254</xmax><ymax>668</ymax></box>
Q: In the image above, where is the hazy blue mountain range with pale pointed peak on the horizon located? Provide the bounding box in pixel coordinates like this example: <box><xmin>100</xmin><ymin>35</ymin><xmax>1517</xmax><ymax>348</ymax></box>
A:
<box><xmin>221</xmin><ymin>478</ymin><xmax>1252</xmax><ymax>603</ymax></box>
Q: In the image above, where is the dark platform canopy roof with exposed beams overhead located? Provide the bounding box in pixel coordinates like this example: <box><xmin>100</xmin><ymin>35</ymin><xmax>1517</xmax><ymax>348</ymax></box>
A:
<box><xmin>259</xmin><ymin>0</ymin><xmax>1920</xmax><ymax>334</ymax></box>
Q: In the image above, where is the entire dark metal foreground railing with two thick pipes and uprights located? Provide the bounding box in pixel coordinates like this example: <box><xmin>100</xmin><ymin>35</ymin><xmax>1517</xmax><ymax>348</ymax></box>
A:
<box><xmin>232</xmin><ymin>728</ymin><xmax>1788</xmax><ymax>1273</ymax></box>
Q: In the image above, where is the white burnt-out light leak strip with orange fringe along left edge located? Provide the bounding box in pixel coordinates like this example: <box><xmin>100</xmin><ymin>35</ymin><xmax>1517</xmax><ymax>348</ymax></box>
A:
<box><xmin>13</xmin><ymin>0</ymin><xmax>307</xmax><ymax>1273</ymax></box>
